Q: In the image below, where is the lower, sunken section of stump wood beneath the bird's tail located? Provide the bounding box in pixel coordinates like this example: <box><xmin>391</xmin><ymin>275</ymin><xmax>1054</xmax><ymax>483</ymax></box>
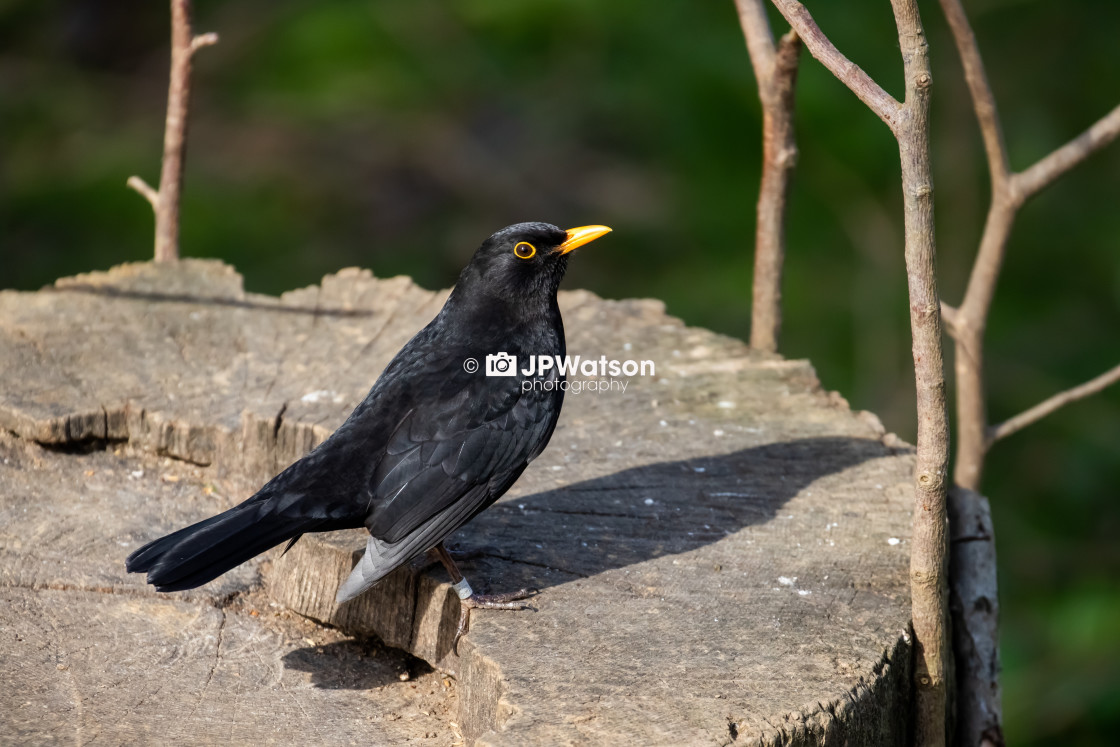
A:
<box><xmin>0</xmin><ymin>432</ymin><xmax>458</xmax><ymax>745</ymax></box>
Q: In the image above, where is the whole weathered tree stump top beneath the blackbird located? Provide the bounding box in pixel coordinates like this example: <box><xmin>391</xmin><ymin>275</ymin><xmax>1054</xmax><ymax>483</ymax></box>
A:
<box><xmin>0</xmin><ymin>260</ymin><xmax>913</xmax><ymax>745</ymax></box>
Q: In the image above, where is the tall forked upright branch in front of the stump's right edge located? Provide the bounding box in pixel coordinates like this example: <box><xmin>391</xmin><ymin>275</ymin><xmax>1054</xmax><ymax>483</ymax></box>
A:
<box><xmin>773</xmin><ymin>0</ymin><xmax>951</xmax><ymax>747</ymax></box>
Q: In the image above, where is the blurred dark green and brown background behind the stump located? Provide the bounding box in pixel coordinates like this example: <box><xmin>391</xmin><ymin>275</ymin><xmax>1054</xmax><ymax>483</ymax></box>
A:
<box><xmin>0</xmin><ymin>0</ymin><xmax>1120</xmax><ymax>745</ymax></box>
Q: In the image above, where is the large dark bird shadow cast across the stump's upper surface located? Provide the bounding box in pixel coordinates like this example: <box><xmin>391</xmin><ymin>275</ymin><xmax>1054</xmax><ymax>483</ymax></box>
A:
<box><xmin>436</xmin><ymin>437</ymin><xmax>897</xmax><ymax>591</ymax></box>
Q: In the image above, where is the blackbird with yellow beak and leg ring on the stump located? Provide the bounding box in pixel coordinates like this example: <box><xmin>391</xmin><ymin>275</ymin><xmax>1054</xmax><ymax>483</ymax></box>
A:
<box><xmin>127</xmin><ymin>223</ymin><xmax>610</xmax><ymax>644</ymax></box>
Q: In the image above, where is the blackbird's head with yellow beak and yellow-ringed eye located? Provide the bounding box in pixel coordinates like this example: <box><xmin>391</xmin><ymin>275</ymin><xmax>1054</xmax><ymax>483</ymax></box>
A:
<box><xmin>456</xmin><ymin>223</ymin><xmax>610</xmax><ymax>301</ymax></box>
